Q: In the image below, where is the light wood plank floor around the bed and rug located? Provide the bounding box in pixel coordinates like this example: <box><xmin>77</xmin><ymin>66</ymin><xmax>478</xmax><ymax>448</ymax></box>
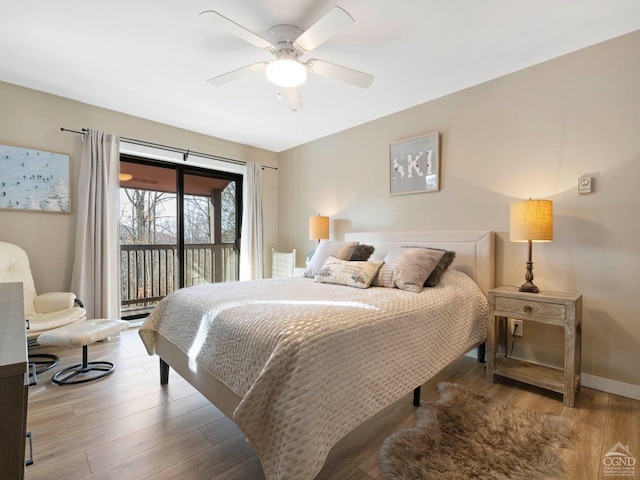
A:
<box><xmin>26</xmin><ymin>329</ymin><xmax>640</xmax><ymax>480</ymax></box>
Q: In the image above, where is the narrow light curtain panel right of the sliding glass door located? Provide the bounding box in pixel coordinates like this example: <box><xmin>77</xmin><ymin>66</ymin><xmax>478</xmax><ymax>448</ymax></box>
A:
<box><xmin>240</xmin><ymin>162</ymin><xmax>263</xmax><ymax>280</ymax></box>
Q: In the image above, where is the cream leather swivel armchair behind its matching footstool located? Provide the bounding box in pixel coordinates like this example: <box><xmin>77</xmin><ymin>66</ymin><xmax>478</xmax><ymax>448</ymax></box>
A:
<box><xmin>0</xmin><ymin>241</ymin><xmax>86</xmax><ymax>373</ymax></box>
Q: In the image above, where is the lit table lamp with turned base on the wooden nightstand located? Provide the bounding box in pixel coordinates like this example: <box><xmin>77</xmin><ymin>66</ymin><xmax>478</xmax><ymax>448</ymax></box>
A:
<box><xmin>509</xmin><ymin>199</ymin><xmax>553</xmax><ymax>293</ymax></box>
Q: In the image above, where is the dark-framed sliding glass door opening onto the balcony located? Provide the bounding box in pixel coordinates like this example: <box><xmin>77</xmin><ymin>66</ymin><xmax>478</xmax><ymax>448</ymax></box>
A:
<box><xmin>120</xmin><ymin>155</ymin><xmax>242</xmax><ymax>318</ymax></box>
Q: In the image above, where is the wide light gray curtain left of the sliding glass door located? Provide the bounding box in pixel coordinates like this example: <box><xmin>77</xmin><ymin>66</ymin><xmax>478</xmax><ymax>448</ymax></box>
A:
<box><xmin>71</xmin><ymin>130</ymin><xmax>120</xmax><ymax>319</ymax></box>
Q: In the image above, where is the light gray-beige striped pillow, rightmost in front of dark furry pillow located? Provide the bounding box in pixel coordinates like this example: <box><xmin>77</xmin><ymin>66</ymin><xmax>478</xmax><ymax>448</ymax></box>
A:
<box><xmin>373</xmin><ymin>248</ymin><xmax>444</xmax><ymax>293</ymax></box>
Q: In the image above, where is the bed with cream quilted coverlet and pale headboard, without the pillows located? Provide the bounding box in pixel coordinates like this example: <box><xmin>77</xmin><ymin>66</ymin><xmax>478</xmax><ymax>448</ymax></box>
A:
<box><xmin>140</xmin><ymin>231</ymin><xmax>494</xmax><ymax>480</ymax></box>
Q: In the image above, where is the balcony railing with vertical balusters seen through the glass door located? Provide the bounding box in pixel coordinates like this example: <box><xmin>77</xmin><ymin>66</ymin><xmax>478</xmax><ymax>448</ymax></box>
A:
<box><xmin>120</xmin><ymin>243</ymin><xmax>238</xmax><ymax>316</ymax></box>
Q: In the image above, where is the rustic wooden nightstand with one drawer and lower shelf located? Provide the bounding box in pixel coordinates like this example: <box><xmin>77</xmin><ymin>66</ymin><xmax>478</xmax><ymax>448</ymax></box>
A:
<box><xmin>487</xmin><ymin>287</ymin><xmax>582</xmax><ymax>407</ymax></box>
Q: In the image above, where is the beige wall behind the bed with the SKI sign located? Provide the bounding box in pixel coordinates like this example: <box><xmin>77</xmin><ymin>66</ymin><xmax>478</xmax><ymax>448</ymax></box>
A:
<box><xmin>279</xmin><ymin>32</ymin><xmax>640</xmax><ymax>386</ymax></box>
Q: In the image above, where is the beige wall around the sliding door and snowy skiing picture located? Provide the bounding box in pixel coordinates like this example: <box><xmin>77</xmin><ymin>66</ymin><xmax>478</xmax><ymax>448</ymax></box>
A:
<box><xmin>0</xmin><ymin>82</ymin><xmax>278</xmax><ymax>293</ymax></box>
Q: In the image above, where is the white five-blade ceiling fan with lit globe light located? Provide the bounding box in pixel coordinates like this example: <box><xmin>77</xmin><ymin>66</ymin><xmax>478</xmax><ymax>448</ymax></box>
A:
<box><xmin>200</xmin><ymin>6</ymin><xmax>373</xmax><ymax>111</ymax></box>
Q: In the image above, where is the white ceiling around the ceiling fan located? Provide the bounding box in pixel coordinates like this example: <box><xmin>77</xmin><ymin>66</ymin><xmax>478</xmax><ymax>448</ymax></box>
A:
<box><xmin>0</xmin><ymin>0</ymin><xmax>640</xmax><ymax>152</ymax></box>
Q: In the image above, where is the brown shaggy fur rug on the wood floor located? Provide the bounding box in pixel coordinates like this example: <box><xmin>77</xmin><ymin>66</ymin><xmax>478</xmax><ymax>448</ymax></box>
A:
<box><xmin>380</xmin><ymin>383</ymin><xmax>573</xmax><ymax>480</ymax></box>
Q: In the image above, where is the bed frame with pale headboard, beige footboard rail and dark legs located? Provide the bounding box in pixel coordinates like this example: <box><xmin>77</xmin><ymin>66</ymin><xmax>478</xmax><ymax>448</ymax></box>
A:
<box><xmin>156</xmin><ymin>231</ymin><xmax>495</xmax><ymax>476</ymax></box>
